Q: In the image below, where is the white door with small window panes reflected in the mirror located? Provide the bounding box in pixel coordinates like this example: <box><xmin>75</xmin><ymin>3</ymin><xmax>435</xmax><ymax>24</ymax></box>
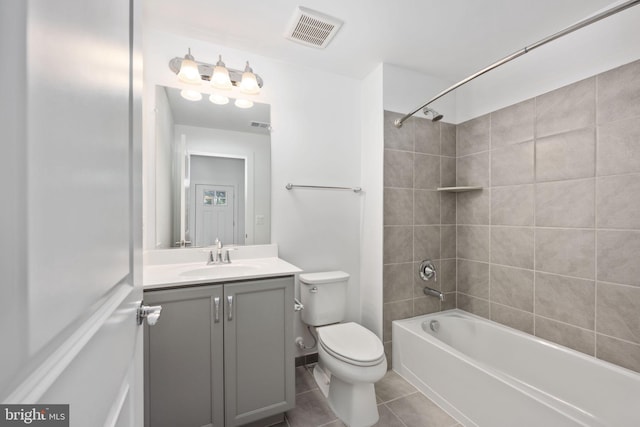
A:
<box><xmin>194</xmin><ymin>184</ymin><xmax>237</xmax><ymax>246</ymax></box>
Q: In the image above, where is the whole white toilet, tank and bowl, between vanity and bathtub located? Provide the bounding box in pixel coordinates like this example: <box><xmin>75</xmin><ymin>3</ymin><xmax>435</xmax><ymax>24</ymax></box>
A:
<box><xmin>300</xmin><ymin>271</ymin><xmax>387</xmax><ymax>427</ymax></box>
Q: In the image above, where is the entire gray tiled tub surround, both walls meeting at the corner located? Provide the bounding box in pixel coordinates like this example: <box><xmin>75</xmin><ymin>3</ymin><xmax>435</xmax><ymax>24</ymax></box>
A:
<box><xmin>383</xmin><ymin>57</ymin><xmax>640</xmax><ymax>371</ymax></box>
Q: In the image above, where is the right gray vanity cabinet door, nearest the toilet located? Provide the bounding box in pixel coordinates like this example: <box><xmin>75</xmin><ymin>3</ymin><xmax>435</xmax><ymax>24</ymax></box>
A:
<box><xmin>224</xmin><ymin>277</ymin><xmax>295</xmax><ymax>427</ymax></box>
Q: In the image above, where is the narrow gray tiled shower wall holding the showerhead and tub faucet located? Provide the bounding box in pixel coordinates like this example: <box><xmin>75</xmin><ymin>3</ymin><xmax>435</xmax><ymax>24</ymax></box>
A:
<box><xmin>383</xmin><ymin>112</ymin><xmax>456</xmax><ymax>368</ymax></box>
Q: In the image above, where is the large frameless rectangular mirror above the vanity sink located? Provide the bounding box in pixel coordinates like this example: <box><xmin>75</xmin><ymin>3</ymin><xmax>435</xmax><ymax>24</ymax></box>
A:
<box><xmin>155</xmin><ymin>86</ymin><xmax>271</xmax><ymax>248</ymax></box>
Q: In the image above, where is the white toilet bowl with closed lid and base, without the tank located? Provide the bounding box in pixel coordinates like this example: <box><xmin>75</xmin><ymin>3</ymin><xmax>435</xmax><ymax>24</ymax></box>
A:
<box><xmin>314</xmin><ymin>322</ymin><xmax>387</xmax><ymax>427</ymax></box>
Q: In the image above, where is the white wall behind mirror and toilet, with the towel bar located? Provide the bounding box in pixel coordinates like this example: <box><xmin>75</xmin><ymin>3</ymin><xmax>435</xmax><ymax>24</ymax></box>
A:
<box><xmin>144</xmin><ymin>29</ymin><xmax>366</xmax><ymax>354</ymax></box>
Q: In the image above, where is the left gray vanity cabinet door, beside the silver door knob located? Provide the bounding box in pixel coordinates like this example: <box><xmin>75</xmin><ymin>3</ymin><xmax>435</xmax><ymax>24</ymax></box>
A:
<box><xmin>144</xmin><ymin>285</ymin><xmax>224</xmax><ymax>427</ymax></box>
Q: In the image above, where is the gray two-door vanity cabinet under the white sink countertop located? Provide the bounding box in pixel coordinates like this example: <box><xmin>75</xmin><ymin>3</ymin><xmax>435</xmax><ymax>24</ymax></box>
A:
<box><xmin>144</xmin><ymin>276</ymin><xmax>295</xmax><ymax>427</ymax></box>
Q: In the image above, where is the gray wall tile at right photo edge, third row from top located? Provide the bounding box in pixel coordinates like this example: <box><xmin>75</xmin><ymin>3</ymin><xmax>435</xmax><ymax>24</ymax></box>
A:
<box><xmin>597</xmin><ymin>173</ymin><xmax>640</xmax><ymax>229</ymax></box>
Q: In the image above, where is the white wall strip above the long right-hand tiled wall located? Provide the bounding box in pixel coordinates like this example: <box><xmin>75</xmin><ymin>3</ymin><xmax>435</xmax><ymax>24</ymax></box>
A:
<box><xmin>455</xmin><ymin>6</ymin><xmax>640</xmax><ymax>123</ymax></box>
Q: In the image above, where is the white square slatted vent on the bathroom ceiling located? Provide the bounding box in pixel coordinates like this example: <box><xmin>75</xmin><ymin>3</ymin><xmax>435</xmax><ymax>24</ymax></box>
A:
<box><xmin>285</xmin><ymin>6</ymin><xmax>342</xmax><ymax>49</ymax></box>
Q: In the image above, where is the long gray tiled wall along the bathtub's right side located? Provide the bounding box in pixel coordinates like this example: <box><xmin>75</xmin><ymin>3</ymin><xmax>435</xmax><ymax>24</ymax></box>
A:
<box><xmin>456</xmin><ymin>61</ymin><xmax>640</xmax><ymax>371</ymax></box>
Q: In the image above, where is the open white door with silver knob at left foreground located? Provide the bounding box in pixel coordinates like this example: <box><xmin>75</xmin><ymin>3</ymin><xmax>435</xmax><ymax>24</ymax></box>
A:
<box><xmin>0</xmin><ymin>0</ymin><xmax>142</xmax><ymax>427</ymax></box>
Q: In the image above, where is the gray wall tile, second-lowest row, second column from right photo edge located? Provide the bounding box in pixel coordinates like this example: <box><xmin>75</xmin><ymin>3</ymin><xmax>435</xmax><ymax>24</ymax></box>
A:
<box><xmin>535</xmin><ymin>273</ymin><xmax>596</xmax><ymax>329</ymax></box>
